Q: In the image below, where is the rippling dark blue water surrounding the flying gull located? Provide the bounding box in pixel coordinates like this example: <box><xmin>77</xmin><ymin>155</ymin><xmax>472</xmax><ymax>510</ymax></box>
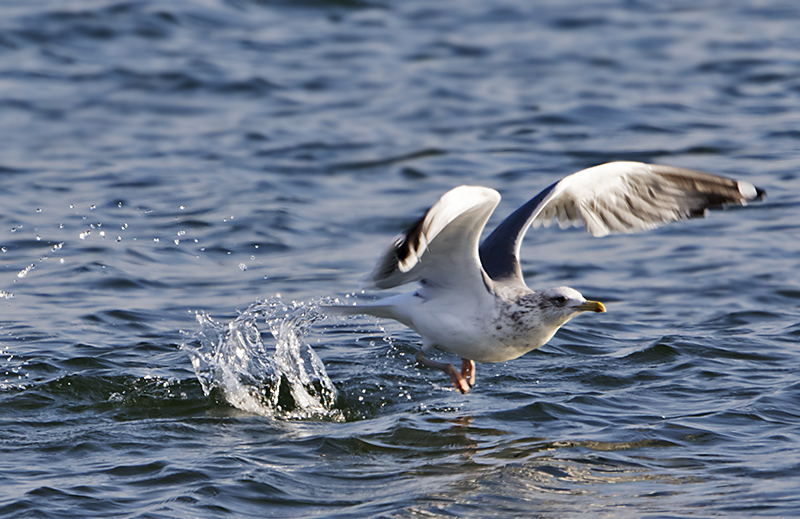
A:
<box><xmin>0</xmin><ymin>0</ymin><xmax>800</xmax><ymax>518</ymax></box>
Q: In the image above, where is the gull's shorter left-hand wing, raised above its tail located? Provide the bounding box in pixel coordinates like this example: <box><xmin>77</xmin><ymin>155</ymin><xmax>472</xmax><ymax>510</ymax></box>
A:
<box><xmin>366</xmin><ymin>186</ymin><xmax>500</xmax><ymax>288</ymax></box>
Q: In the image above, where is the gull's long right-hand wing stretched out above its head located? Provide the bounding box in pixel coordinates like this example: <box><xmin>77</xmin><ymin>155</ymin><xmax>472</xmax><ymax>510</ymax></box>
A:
<box><xmin>480</xmin><ymin>162</ymin><xmax>764</xmax><ymax>283</ymax></box>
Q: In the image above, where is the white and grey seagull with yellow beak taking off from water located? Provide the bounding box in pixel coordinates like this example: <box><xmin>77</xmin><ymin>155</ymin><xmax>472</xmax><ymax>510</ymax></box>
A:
<box><xmin>325</xmin><ymin>162</ymin><xmax>765</xmax><ymax>393</ymax></box>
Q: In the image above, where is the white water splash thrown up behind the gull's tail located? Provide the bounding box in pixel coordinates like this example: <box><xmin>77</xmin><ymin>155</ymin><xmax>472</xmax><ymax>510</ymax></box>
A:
<box><xmin>182</xmin><ymin>298</ymin><xmax>343</xmax><ymax>421</ymax></box>
